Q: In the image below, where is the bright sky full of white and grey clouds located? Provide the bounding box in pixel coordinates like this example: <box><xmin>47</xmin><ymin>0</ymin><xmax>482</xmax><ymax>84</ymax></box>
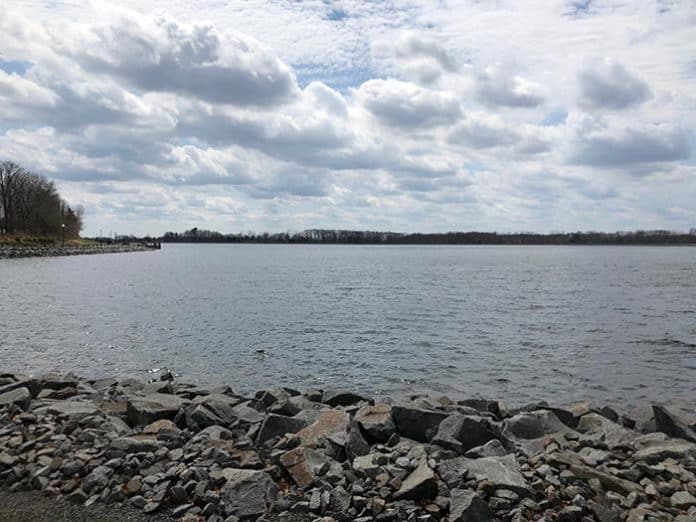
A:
<box><xmin>0</xmin><ymin>0</ymin><xmax>696</xmax><ymax>232</ymax></box>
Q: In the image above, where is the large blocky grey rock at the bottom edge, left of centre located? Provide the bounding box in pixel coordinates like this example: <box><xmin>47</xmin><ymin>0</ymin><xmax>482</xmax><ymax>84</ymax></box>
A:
<box><xmin>216</xmin><ymin>468</ymin><xmax>278</xmax><ymax>520</ymax></box>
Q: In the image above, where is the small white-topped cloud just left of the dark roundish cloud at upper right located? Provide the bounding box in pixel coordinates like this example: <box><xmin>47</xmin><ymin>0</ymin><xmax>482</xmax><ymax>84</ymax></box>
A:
<box><xmin>477</xmin><ymin>66</ymin><xmax>546</xmax><ymax>107</ymax></box>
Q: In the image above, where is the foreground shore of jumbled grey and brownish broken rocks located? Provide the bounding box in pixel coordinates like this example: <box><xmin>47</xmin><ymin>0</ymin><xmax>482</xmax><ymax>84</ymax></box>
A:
<box><xmin>0</xmin><ymin>374</ymin><xmax>696</xmax><ymax>522</ymax></box>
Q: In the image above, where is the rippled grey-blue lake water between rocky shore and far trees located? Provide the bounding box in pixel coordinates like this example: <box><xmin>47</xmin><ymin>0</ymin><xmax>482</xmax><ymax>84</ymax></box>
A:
<box><xmin>0</xmin><ymin>245</ymin><xmax>696</xmax><ymax>407</ymax></box>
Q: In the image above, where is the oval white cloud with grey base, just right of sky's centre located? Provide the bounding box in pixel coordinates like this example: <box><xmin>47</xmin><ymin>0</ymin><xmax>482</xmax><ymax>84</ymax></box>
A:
<box><xmin>356</xmin><ymin>79</ymin><xmax>461</xmax><ymax>130</ymax></box>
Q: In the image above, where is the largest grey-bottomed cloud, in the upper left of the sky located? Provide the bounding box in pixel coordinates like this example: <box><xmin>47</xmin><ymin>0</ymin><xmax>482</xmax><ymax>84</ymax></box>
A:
<box><xmin>69</xmin><ymin>14</ymin><xmax>297</xmax><ymax>106</ymax></box>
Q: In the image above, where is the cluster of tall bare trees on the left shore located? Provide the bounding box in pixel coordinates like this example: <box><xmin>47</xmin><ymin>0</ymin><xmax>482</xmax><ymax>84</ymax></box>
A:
<box><xmin>0</xmin><ymin>161</ymin><xmax>82</xmax><ymax>239</ymax></box>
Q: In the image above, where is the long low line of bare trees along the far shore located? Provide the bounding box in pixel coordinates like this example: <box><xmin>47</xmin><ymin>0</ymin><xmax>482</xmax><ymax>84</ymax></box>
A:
<box><xmin>160</xmin><ymin>228</ymin><xmax>696</xmax><ymax>245</ymax></box>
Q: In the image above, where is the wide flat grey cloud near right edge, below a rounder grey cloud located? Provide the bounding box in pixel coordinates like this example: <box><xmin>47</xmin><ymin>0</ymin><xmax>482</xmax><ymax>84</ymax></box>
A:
<box><xmin>571</xmin><ymin>120</ymin><xmax>691</xmax><ymax>168</ymax></box>
